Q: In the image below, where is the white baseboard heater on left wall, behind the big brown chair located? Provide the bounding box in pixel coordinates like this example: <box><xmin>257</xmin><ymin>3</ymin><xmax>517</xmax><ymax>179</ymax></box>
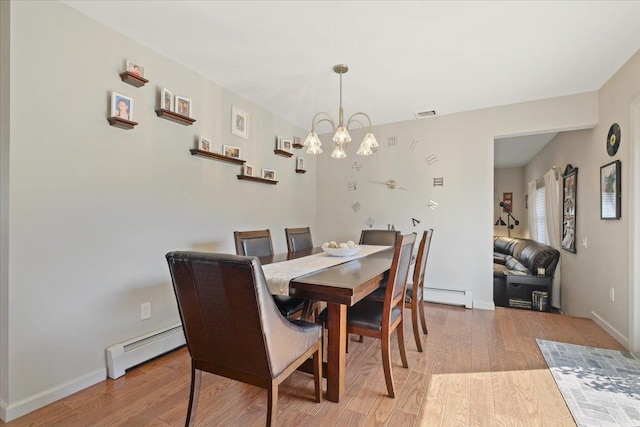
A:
<box><xmin>107</xmin><ymin>323</ymin><xmax>186</xmax><ymax>379</ymax></box>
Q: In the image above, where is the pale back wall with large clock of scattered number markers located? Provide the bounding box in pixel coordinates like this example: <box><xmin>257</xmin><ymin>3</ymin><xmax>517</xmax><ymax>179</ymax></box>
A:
<box><xmin>317</xmin><ymin>93</ymin><xmax>598</xmax><ymax>309</ymax></box>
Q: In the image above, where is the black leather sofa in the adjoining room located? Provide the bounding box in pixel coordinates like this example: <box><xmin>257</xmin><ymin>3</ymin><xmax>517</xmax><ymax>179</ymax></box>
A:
<box><xmin>493</xmin><ymin>236</ymin><xmax>560</xmax><ymax>307</ymax></box>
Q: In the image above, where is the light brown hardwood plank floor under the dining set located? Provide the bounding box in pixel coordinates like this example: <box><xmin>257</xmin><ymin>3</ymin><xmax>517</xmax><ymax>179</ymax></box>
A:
<box><xmin>0</xmin><ymin>304</ymin><xmax>623</xmax><ymax>426</ymax></box>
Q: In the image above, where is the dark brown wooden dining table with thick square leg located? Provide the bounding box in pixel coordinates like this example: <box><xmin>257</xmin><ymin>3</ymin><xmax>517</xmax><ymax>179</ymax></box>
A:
<box><xmin>260</xmin><ymin>245</ymin><xmax>393</xmax><ymax>402</ymax></box>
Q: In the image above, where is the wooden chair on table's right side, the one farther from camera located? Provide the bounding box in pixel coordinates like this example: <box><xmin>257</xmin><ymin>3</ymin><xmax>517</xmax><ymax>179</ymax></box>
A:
<box><xmin>367</xmin><ymin>229</ymin><xmax>433</xmax><ymax>352</ymax></box>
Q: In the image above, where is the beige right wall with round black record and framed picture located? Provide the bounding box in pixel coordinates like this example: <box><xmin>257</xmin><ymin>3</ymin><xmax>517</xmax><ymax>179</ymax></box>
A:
<box><xmin>525</xmin><ymin>52</ymin><xmax>640</xmax><ymax>347</ymax></box>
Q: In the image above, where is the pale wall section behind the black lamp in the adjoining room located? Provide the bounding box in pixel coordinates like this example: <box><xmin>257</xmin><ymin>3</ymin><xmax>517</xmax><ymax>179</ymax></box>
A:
<box><xmin>493</xmin><ymin>167</ymin><xmax>529</xmax><ymax>238</ymax></box>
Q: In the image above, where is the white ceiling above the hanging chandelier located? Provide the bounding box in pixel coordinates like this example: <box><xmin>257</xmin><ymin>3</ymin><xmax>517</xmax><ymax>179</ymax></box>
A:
<box><xmin>63</xmin><ymin>0</ymin><xmax>640</xmax><ymax>131</ymax></box>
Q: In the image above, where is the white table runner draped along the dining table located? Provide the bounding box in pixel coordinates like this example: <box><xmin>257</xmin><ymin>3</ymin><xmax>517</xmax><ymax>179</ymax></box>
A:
<box><xmin>262</xmin><ymin>245</ymin><xmax>391</xmax><ymax>295</ymax></box>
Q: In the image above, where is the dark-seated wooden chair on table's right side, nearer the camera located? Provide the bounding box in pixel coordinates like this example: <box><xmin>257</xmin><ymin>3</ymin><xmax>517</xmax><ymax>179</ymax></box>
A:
<box><xmin>320</xmin><ymin>233</ymin><xmax>416</xmax><ymax>397</ymax></box>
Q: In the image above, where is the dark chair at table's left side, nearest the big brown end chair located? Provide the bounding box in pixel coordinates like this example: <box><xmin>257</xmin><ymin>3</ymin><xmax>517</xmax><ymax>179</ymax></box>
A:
<box><xmin>233</xmin><ymin>230</ymin><xmax>308</xmax><ymax>317</ymax></box>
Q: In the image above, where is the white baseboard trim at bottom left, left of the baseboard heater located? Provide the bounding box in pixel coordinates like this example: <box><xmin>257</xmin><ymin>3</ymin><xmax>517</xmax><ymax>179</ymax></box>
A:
<box><xmin>0</xmin><ymin>368</ymin><xmax>107</xmax><ymax>422</ymax></box>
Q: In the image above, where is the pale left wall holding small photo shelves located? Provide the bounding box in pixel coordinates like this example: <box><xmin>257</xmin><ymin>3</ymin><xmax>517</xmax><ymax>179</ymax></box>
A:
<box><xmin>0</xmin><ymin>1</ymin><xmax>316</xmax><ymax>417</ymax></box>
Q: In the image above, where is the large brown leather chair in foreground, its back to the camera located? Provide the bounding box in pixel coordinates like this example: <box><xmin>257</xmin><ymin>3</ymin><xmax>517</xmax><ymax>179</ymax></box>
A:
<box><xmin>166</xmin><ymin>252</ymin><xmax>322</xmax><ymax>426</ymax></box>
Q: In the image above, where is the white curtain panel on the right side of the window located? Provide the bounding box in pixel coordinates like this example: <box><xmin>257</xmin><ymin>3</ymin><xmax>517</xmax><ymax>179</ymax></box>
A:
<box><xmin>544</xmin><ymin>169</ymin><xmax>562</xmax><ymax>308</ymax></box>
